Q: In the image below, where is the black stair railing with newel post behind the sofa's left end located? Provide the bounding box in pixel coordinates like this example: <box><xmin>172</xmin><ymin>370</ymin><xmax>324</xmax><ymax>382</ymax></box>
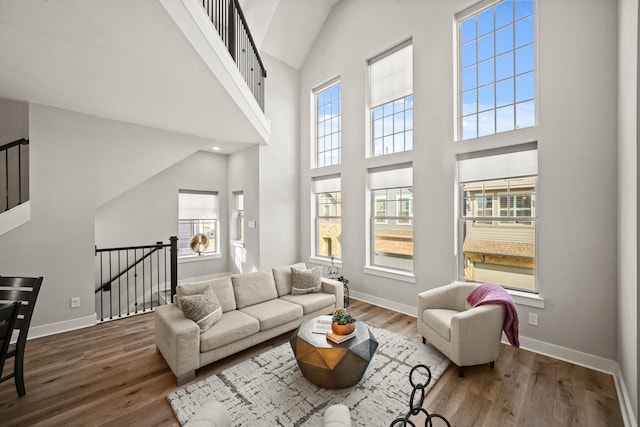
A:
<box><xmin>95</xmin><ymin>236</ymin><xmax>178</xmax><ymax>321</ymax></box>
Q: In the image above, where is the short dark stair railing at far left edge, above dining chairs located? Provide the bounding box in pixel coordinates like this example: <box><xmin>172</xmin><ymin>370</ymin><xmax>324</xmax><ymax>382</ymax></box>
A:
<box><xmin>0</xmin><ymin>138</ymin><xmax>29</xmax><ymax>212</ymax></box>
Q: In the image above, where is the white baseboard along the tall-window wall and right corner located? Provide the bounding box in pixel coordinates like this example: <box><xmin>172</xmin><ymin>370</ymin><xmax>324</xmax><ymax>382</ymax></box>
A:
<box><xmin>349</xmin><ymin>291</ymin><xmax>638</xmax><ymax>427</ymax></box>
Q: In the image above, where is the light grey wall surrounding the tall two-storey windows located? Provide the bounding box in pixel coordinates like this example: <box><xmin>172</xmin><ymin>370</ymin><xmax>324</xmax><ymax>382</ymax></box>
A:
<box><xmin>300</xmin><ymin>0</ymin><xmax>617</xmax><ymax>360</ymax></box>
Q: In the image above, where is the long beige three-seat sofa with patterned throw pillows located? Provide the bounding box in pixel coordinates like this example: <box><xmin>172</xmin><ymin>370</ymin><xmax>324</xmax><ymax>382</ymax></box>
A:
<box><xmin>154</xmin><ymin>263</ymin><xmax>344</xmax><ymax>385</ymax></box>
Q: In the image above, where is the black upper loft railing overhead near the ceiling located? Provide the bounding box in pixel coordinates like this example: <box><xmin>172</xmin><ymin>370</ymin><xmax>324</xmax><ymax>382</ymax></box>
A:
<box><xmin>202</xmin><ymin>0</ymin><xmax>267</xmax><ymax>111</ymax></box>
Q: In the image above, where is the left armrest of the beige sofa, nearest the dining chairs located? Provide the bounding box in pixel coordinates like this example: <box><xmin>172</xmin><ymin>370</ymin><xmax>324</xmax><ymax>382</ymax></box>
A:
<box><xmin>154</xmin><ymin>304</ymin><xmax>200</xmax><ymax>383</ymax></box>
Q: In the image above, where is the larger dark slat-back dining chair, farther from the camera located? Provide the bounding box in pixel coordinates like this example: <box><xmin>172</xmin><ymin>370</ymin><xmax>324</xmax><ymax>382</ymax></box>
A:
<box><xmin>0</xmin><ymin>276</ymin><xmax>43</xmax><ymax>396</ymax></box>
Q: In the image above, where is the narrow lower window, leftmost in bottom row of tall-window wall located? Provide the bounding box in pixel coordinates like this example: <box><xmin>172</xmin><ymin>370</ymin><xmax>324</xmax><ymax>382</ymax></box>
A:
<box><xmin>313</xmin><ymin>177</ymin><xmax>342</xmax><ymax>259</ymax></box>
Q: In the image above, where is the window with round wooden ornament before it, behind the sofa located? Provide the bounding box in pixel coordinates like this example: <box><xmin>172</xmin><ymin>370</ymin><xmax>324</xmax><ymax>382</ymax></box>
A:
<box><xmin>178</xmin><ymin>190</ymin><xmax>219</xmax><ymax>257</ymax></box>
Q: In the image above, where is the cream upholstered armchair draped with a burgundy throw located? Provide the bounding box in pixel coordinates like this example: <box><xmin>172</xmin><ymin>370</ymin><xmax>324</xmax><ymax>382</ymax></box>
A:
<box><xmin>417</xmin><ymin>282</ymin><xmax>504</xmax><ymax>377</ymax></box>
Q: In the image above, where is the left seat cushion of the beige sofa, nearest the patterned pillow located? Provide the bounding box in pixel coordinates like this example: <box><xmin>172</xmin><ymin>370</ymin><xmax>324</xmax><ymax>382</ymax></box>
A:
<box><xmin>200</xmin><ymin>310</ymin><xmax>260</xmax><ymax>353</ymax></box>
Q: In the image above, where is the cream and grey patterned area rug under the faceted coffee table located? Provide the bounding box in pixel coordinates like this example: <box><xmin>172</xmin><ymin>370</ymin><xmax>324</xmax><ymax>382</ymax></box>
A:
<box><xmin>167</xmin><ymin>326</ymin><xmax>449</xmax><ymax>427</ymax></box>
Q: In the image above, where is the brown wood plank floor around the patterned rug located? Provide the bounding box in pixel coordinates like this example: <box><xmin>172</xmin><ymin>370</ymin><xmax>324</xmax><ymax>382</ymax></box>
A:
<box><xmin>0</xmin><ymin>301</ymin><xmax>623</xmax><ymax>427</ymax></box>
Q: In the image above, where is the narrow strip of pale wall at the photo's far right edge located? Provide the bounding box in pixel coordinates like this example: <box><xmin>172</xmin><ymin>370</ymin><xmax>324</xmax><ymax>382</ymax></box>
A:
<box><xmin>617</xmin><ymin>0</ymin><xmax>640</xmax><ymax>420</ymax></box>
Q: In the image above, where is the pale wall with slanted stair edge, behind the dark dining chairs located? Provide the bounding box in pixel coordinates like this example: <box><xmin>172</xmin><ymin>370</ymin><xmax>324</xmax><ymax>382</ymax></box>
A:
<box><xmin>0</xmin><ymin>104</ymin><xmax>215</xmax><ymax>335</ymax></box>
